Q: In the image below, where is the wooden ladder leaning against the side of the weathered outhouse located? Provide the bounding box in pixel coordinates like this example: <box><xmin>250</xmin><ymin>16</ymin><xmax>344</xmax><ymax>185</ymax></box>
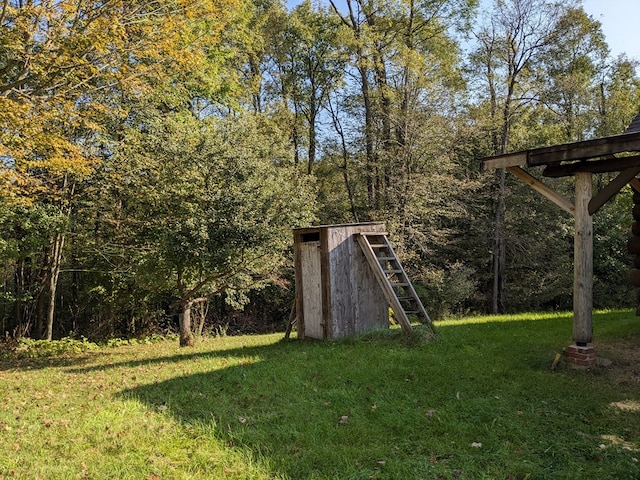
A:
<box><xmin>356</xmin><ymin>232</ymin><xmax>436</xmax><ymax>336</ymax></box>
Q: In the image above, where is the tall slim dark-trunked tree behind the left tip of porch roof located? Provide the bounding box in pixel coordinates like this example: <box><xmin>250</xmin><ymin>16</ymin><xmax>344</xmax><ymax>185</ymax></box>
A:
<box><xmin>471</xmin><ymin>0</ymin><xmax>559</xmax><ymax>313</ymax></box>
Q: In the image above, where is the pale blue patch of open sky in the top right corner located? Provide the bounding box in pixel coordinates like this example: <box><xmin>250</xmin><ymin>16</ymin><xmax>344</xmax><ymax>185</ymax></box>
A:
<box><xmin>583</xmin><ymin>0</ymin><xmax>640</xmax><ymax>61</ymax></box>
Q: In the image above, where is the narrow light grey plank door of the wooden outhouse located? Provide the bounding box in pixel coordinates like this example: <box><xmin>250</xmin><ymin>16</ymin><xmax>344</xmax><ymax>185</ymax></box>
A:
<box><xmin>300</xmin><ymin>241</ymin><xmax>324</xmax><ymax>340</ymax></box>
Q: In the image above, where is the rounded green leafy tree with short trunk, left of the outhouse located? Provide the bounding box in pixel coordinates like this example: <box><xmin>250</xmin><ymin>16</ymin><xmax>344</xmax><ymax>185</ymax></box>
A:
<box><xmin>105</xmin><ymin>113</ymin><xmax>313</xmax><ymax>346</ymax></box>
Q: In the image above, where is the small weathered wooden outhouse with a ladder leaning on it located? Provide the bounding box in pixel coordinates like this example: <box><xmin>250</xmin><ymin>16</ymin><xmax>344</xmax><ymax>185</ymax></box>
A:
<box><xmin>293</xmin><ymin>223</ymin><xmax>389</xmax><ymax>339</ymax></box>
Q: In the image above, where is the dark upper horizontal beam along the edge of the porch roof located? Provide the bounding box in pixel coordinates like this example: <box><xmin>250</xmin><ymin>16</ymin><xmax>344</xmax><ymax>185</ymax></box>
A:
<box><xmin>527</xmin><ymin>132</ymin><xmax>640</xmax><ymax>166</ymax></box>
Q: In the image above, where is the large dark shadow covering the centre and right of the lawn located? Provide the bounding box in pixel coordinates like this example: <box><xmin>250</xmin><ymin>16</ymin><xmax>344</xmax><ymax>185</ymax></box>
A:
<box><xmin>114</xmin><ymin>313</ymin><xmax>640</xmax><ymax>479</ymax></box>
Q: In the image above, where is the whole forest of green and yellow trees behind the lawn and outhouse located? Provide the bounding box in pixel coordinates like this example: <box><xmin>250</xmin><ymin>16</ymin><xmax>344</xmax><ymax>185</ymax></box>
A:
<box><xmin>0</xmin><ymin>0</ymin><xmax>640</xmax><ymax>344</ymax></box>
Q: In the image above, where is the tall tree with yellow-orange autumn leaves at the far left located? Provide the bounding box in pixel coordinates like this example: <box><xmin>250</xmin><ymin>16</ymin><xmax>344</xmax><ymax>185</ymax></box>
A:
<box><xmin>0</xmin><ymin>0</ymin><xmax>240</xmax><ymax>339</ymax></box>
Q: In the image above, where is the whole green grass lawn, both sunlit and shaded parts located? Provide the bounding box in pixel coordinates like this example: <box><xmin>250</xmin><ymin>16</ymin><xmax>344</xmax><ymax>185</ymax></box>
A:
<box><xmin>0</xmin><ymin>311</ymin><xmax>640</xmax><ymax>480</ymax></box>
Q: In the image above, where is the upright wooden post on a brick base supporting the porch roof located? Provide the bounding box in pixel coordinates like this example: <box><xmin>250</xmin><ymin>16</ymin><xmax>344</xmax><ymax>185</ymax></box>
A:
<box><xmin>573</xmin><ymin>172</ymin><xmax>593</xmax><ymax>346</ymax></box>
